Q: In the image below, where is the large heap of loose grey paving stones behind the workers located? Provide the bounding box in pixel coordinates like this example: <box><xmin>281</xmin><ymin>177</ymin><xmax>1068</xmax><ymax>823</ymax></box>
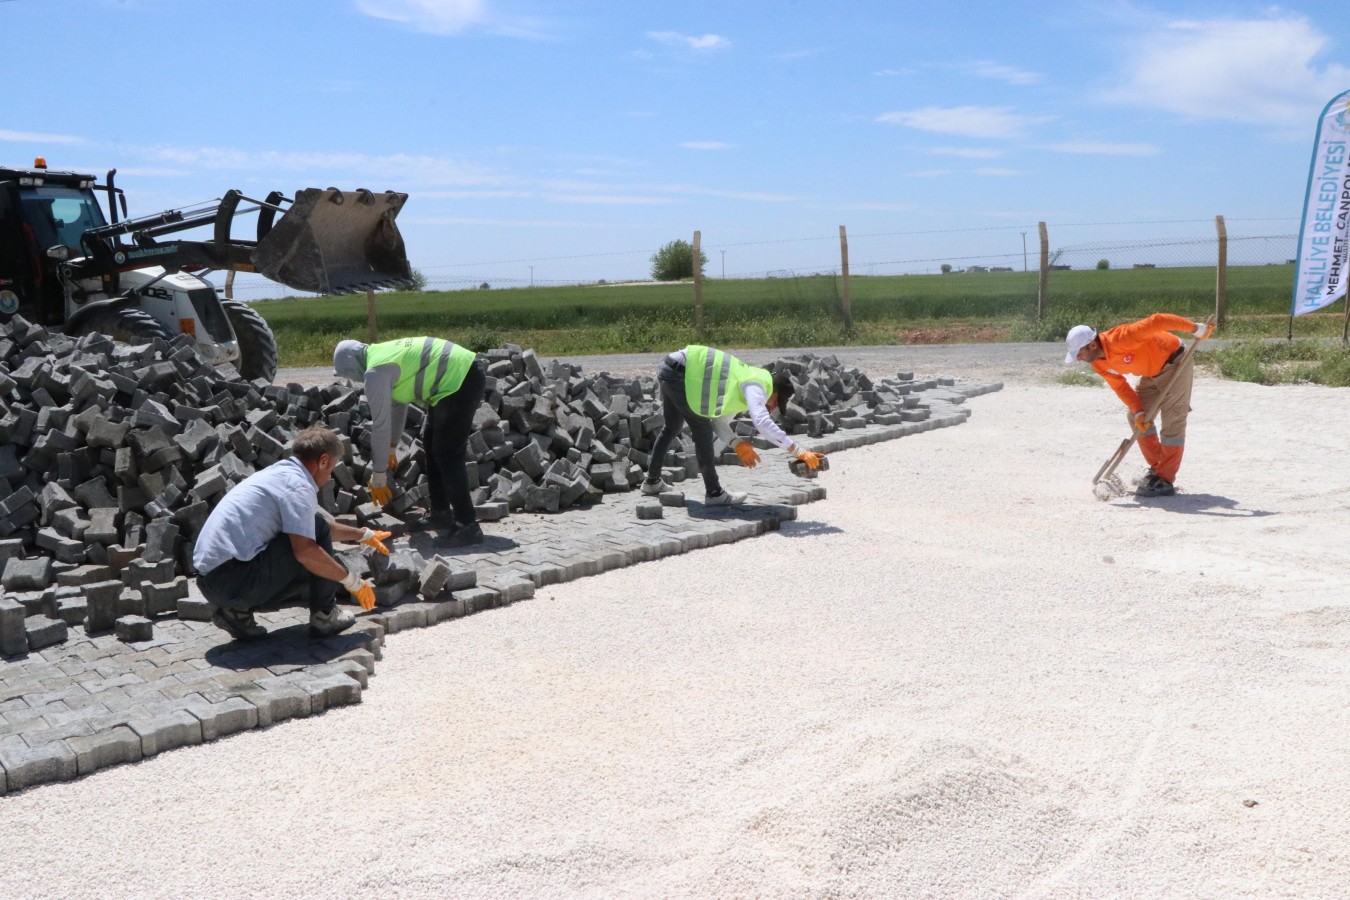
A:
<box><xmin>0</xmin><ymin>316</ymin><xmax>961</xmax><ymax>656</ymax></box>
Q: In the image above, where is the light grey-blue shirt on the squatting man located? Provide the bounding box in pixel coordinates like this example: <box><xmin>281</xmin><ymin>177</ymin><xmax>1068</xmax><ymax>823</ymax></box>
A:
<box><xmin>192</xmin><ymin>457</ymin><xmax>319</xmax><ymax>575</ymax></box>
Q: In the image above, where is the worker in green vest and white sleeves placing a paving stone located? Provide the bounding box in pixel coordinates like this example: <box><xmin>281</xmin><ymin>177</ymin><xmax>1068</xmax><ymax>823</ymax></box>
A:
<box><xmin>643</xmin><ymin>344</ymin><xmax>824</xmax><ymax>506</ymax></box>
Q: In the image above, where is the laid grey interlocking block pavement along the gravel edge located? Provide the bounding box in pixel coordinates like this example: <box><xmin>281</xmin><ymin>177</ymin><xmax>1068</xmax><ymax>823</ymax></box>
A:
<box><xmin>0</xmin><ymin>383</ymin><xmax>1002</xmax><ymax>795</ymax></box>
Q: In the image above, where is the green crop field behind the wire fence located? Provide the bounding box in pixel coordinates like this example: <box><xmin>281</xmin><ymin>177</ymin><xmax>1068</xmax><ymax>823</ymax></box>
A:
<box><xmin>254</xmin><ymin>266</ymin><xmax>1341</xmax><ymax>366</ymax></box>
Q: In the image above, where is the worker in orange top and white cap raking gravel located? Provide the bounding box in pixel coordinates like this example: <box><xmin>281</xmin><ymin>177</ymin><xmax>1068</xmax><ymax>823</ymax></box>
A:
<box><xmin>1064</xmin><ymin>313</ymin><xmax>1214</xmax><ymax>497</ymax></box>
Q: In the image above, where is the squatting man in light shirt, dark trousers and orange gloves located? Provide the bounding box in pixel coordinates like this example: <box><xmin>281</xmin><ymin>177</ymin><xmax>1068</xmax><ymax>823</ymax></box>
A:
<box><xmin>192</xmin><ymin>425</ymin><xmax>389</xmax><ymax>641</ymax></box>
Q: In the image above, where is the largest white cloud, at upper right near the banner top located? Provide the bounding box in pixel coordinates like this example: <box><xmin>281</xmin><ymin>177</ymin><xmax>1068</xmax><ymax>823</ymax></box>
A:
<box><xmin>1107</xmin><ymin>11</ymin><xmax>1350</xmax><ymax>125</ymax></box>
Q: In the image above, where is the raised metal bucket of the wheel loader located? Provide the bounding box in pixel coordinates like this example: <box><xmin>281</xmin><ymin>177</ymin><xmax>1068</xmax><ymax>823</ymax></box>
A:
<box><xmin>251</xmin><ymin>188</ymin><xmax>412</xmax><ymax>294</ymax></box>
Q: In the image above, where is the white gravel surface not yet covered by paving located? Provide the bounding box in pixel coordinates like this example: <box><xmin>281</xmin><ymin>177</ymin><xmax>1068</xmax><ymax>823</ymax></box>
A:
<box><xmin>0</xmin><ymin>356</ymin><xmax>1350</xmax><ymax>897</ymax></box>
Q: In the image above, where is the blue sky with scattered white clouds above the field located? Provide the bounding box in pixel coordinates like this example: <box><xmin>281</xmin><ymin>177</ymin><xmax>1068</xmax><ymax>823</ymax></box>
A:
<box><xmin>0</xmin><ymin>0</ymin><xmax>1350</xmax><ymax>295</ymax></box>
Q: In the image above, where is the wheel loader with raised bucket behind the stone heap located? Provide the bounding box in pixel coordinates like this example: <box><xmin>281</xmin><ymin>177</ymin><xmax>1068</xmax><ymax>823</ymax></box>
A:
<box><xmin>0</xmin><ymin>157</ymin><xmax>412</xmax><ymax>381</ymax></box>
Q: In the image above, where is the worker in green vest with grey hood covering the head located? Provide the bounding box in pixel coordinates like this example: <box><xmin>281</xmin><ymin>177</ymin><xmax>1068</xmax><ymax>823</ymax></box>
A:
<box><xmin>333</xmin><ymin>337</ymin><xmax>487</xmax><ymax>546</ymax></box>
